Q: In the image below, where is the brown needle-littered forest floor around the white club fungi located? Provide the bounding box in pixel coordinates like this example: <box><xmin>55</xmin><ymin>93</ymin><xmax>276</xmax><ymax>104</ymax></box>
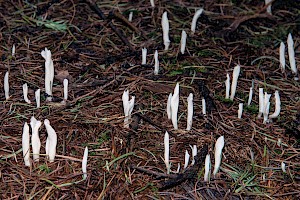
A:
<box><xmin>0</xmin><ymin>0</ymin><xmax>300</xmax><ymax>199</ymax></box>
